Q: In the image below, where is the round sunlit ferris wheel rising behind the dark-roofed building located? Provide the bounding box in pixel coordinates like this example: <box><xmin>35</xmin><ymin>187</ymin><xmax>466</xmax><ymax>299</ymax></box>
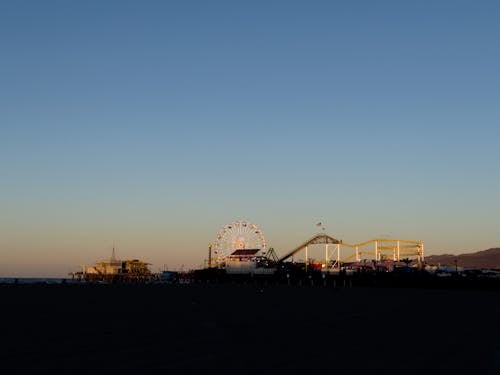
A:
<box><xmin>213</xmin><ymin>221</ymin><xmax>266</xmax><ymax>257</ymax></box>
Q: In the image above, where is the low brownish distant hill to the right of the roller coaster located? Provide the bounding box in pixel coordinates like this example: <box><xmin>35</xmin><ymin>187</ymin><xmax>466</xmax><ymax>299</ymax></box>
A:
<box><xmin>425</xmin><ymin>247</ymin><xmax>500</xmax><ymax>269</ymax></box>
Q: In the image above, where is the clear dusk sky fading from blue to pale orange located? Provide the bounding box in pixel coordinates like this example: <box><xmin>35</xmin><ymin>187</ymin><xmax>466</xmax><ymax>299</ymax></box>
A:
<box><xmin>0</xmin><ymin>0</ymin><xmax>500</xmax><ymax>277</ymax></box>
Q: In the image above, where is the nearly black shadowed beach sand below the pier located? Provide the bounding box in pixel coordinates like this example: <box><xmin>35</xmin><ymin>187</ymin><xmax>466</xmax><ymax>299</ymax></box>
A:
<box><xmin>0</xmin><ymin>285</ymin><xmax>500</xmax><ymax>374</ymax></box>
